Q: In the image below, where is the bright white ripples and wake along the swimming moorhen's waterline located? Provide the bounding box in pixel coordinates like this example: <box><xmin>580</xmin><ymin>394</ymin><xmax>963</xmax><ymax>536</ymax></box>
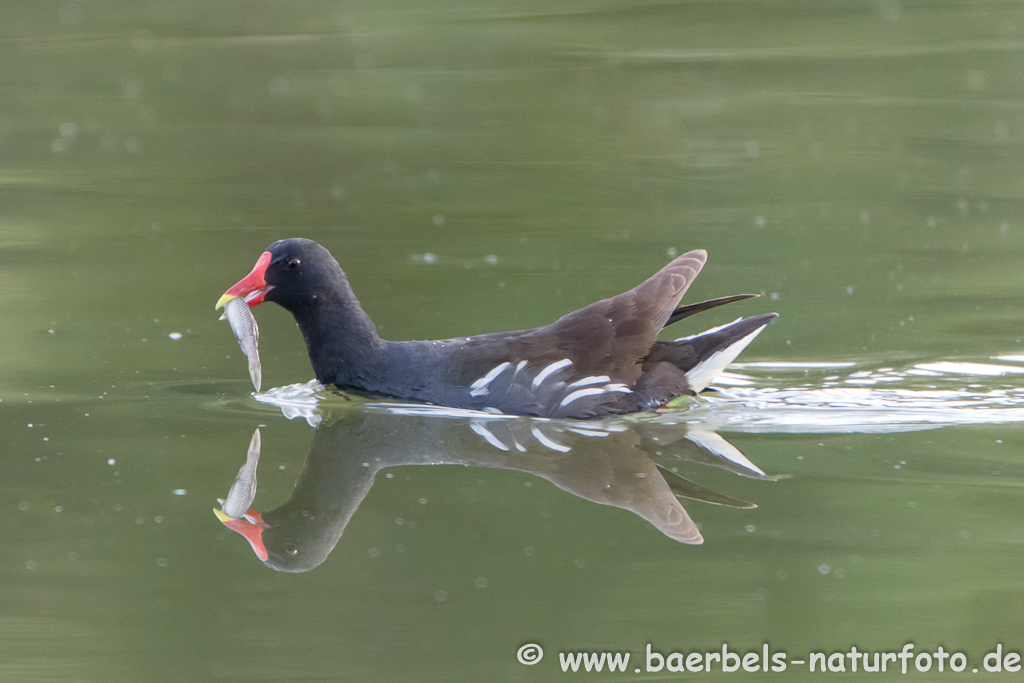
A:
<box><xmin>256</xmin><ymin>355</ymin><xmax>1024</xmax><ymax>433</ymax></box>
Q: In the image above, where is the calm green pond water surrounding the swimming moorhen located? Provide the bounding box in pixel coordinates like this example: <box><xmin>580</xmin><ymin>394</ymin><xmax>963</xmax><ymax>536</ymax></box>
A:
<box><xmin>0</xmin><ymin>0</ymin><xmax>1024</xmax><ymax>682</ymax></box>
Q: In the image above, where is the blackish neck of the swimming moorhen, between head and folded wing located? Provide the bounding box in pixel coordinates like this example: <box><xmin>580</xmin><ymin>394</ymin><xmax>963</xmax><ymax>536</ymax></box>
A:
<box><xmin>295</xmin><ymin>280</ymin><xmax>381</xmax><ymax>391</ymax></box>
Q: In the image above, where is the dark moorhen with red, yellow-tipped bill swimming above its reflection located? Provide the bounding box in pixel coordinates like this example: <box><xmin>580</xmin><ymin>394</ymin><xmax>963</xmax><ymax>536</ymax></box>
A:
<box><xmin>217</xmin><ymin>239</ymin><xmax>778</xmax><ymax>419</ymax></box>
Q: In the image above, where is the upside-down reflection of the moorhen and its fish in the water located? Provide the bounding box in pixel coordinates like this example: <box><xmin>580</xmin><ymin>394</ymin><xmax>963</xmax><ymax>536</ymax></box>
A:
<box><xmin>216</xmin><ymin>411</ymin><xmax>774</xmax><ymax>572</ymax></box>
